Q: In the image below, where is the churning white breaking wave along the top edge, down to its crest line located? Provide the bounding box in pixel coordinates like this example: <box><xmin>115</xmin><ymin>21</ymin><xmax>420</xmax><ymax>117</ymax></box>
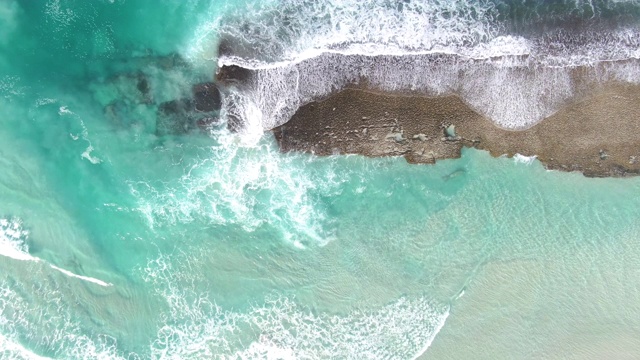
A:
<box><xmin>206</xmin><ymin>0</ymin><xmax>640</xmax><ymax>68</ymax></box>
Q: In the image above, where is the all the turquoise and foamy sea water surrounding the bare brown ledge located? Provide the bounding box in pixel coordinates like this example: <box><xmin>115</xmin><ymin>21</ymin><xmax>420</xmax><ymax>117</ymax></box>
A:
<box><xmin>0</xmin><ymin>0</ymin><xmax>640</xmax><ymax>359</ymax></box>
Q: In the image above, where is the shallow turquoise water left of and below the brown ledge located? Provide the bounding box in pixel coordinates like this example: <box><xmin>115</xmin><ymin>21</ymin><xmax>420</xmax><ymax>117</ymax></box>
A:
<box><xmin>0</xmin><ymin>0</ymin><xmax>640</xmax><ymax>359</ymax></box>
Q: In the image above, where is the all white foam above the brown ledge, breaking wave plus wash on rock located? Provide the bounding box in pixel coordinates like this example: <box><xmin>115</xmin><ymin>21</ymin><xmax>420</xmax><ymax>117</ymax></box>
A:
<box><xmin>190</xmin><ymin>0</ymin><xmax>640</xmax><ymax>133</ymax></box>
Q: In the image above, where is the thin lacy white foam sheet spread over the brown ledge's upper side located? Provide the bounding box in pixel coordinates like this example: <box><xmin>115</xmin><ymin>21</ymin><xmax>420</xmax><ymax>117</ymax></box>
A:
<box><xmin>223</xmin><ymin>53</ymin><xmax>579</xmax><ymax>129</ymax></box>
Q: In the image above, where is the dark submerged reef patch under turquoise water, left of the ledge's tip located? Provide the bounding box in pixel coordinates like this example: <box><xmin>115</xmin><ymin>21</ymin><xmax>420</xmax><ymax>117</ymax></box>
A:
<box><xmin>97</xmin><ymin>54</ymin><xmax>222</xmax><ymax>137</ymax></box>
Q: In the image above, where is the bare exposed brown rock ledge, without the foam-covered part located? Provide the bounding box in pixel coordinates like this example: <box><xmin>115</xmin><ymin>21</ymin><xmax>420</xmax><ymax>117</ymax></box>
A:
<box><xmin>273</xmin><ymin>83</ymin><xmax>640</xmax><ymax>177</ymax></box>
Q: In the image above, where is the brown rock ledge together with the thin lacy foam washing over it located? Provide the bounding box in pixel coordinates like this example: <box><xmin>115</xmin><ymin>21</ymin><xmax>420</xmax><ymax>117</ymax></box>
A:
<box><xmin>215</xmin><ymin>32</ymin><xmax>640</xmax><ymax>177</ymax></box>
